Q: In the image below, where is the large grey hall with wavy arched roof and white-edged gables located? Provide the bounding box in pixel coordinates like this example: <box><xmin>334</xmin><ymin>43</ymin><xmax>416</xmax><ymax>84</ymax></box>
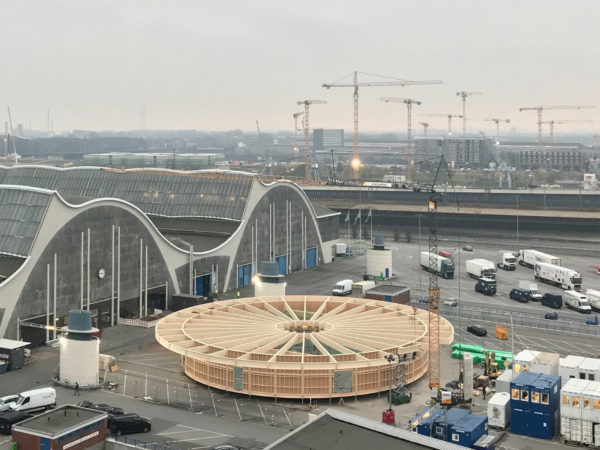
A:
<box><xmin>0</xmin><ymin>166</ymin><xmax>339</xmax><ymax>344</ymax></box>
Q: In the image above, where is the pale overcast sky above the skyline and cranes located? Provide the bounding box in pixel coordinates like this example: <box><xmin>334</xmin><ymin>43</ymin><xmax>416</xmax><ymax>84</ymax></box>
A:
<box><xmin>0</xmin><ymin>0</ymin><xmax>600</xmax><ymax>134</ymax></box>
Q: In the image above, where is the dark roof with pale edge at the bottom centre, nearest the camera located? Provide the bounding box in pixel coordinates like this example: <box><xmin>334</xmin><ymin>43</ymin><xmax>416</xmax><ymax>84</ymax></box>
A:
<box><xmin>265</xmin><ymin>409</ymin><xmax>464</xmax><ymax>450</ymax></box>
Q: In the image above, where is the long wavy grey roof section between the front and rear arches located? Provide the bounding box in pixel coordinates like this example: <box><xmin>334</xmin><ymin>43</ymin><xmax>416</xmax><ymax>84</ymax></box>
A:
<box><xmin>0</xmin><ymin>166</ymin><xmax>258</xmax><ymax>220</ymax></box>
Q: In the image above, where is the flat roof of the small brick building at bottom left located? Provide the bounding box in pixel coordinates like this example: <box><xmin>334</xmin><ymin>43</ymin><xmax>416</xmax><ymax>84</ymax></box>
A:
<box><xmin>13</xmin><ymin>405</ymin><xmax>108</xmax><ymax>439</ymax></box>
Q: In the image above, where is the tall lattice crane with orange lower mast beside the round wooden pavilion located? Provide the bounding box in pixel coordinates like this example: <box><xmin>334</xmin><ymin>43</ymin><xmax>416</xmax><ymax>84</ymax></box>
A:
<box><xmin>427</xmin><ymin>155</ymin><xmax>452</xmax><ymax>398</ymax></box>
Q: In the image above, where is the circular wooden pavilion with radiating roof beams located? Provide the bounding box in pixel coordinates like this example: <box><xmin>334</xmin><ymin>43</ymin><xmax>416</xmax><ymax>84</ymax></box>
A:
<box><xmin>156</xmin><ymin>295</ymin><xmax>454</xmax><ymax>398</ymax></box>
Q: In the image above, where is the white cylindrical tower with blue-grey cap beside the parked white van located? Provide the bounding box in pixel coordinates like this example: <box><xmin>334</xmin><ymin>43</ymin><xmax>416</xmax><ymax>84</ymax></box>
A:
<box><xmin>59</xmin><ymin>310</ymin><xmax>100</xmax><ymax>387</ymax></box>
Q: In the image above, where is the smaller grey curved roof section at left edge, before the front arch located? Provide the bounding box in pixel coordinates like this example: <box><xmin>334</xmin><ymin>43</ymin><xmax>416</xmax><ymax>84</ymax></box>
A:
<box><xmin>0</xmin><ymin>186</ymin><xmax>52</xmax><ymax>257</ymax></box>
